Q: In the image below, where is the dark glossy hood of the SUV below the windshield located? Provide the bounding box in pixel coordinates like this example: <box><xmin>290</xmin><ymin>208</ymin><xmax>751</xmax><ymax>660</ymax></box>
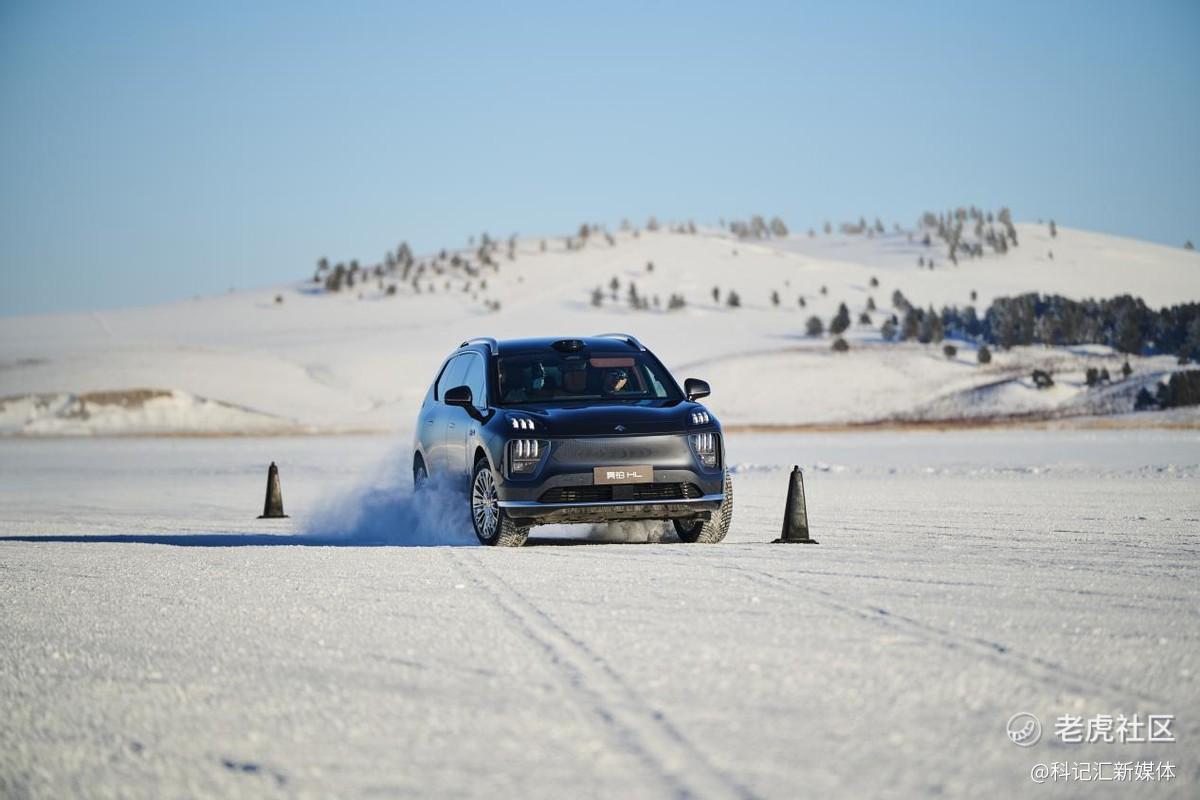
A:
<box><xmin>504</xmin><ymin>399</ymin><xmax>698</xmax><ymax>437</ymax></box>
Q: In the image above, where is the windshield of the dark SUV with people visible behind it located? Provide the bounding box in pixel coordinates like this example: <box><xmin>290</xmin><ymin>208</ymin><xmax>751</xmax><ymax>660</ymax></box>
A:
<box><xmin>497</xmin><ymin>350</ymin><xmax>679</xmax><ymax>405</ymax></box>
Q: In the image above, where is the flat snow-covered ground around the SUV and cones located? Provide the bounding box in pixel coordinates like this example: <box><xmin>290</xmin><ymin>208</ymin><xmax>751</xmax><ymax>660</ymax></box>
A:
<box><xmin>0</xmin><ymin>431</ymin><xmax>1200</xmax><ymax>798</ymax></box>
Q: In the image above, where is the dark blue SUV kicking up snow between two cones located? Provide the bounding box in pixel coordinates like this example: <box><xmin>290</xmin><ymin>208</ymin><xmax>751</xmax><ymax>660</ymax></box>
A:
<box><xmin>413</xmin><ymin>333</ymin><xmax>733</xmax><ymax>547</ymax></box>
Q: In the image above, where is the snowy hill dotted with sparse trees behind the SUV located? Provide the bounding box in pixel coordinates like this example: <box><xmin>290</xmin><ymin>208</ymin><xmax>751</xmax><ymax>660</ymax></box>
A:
<box><xmin>0</xmin><ymin>223</ymin><xmax>1200</xmax><ymax>435</ymax></box>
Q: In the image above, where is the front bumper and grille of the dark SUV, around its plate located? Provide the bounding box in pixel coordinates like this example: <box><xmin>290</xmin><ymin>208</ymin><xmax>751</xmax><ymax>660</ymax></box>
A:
<box><xmin>499</xmin><ymin>434</ymin><xmax>725</xmax><ymax>525</ymax></box>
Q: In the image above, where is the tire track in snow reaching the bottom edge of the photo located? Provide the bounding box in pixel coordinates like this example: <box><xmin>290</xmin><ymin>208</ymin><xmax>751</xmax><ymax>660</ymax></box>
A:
<box><xmin>450</xmin><ymin>552</ymin><xmax>757</xmax><ymax>800</ymax></box>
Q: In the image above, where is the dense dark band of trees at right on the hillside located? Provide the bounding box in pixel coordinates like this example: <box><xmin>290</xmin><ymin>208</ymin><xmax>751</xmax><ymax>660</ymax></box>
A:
<box><xmin>893</xmin><ymin>293</ymin><xmax>1200</xmax><ymax>361</ymax></box>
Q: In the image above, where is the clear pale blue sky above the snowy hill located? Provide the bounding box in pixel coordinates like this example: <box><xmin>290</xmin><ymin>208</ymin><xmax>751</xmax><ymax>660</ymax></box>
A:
<box><xmin>0</xmin><ymin>0</ymin><xmax>1200</xmax><ymax>314</ymax></box>
